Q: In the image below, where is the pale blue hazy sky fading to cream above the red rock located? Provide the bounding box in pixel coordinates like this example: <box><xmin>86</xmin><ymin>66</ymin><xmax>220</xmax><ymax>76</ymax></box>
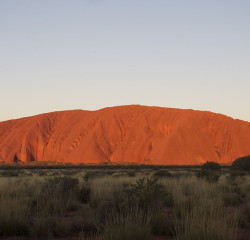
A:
<box><xmin>0</xmin><ymin>0</ymin><xmax>250</xmax><ymax>121</ymax></box>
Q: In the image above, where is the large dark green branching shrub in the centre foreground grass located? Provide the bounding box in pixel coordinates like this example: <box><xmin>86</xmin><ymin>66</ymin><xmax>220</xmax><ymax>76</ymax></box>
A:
<box><xmin>99</xmin><ymin>178</ymin><xmax>173</xmax><ymax>228</ymax></box>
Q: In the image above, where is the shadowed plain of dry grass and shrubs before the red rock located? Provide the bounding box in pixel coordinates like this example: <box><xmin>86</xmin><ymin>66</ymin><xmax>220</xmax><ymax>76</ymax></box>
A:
<box><xmin>0</xmin><ymin>167</ymin><xmax>250</xmax><ymax>240</ymax></box>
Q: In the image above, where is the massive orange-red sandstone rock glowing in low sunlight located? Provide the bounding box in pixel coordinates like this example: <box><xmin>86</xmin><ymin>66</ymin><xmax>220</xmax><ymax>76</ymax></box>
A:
<box><xmin>0</xmin><ymin>105</ymin><xmax>250</xmax><ymax>165</ymax></box>
